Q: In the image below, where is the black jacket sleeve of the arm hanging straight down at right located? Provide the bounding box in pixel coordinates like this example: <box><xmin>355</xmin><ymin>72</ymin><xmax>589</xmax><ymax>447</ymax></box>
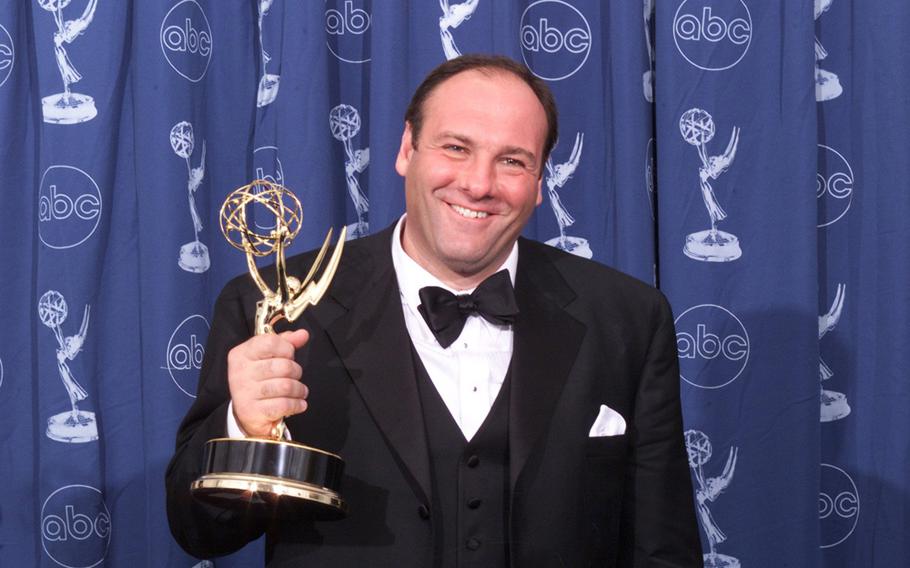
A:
<box><xmin>619</xmin><ymin>294</ymin><xmax>703</xmax><ymax>568</ymax></box>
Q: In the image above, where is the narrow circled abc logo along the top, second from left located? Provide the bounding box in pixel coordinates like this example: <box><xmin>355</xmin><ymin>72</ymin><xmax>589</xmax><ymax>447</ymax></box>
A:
<box><xmin>161</xmin><ymin>0</ymin><xmax>212</xmax><ymax>83</ymax></box>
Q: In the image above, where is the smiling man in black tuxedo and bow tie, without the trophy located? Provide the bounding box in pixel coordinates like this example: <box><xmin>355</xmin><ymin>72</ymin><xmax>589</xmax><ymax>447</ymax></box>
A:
<box><xmin>167</xmin><ymin>56</ymin><xmax>701</xmax><ymax>568</ymax></box>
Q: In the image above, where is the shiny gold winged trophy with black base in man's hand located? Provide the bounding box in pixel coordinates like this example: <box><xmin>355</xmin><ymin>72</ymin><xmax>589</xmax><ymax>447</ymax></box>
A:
<box><xmin>191</xmin><ymin>180</ymin><xmax>347</xmax><ymax>519</ymax></box>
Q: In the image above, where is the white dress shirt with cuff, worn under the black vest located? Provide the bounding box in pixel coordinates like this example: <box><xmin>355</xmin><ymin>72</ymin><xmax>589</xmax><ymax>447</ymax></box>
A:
<box><xmin>227</xmin><ymin>214</ymin><xmax>518</xmax><ymax>441</ymax></box>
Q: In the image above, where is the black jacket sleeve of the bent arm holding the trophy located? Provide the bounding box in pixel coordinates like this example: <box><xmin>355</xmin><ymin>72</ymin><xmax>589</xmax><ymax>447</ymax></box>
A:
<box><xmin>165</xmin><ymin>281</ymin><xmax>266</xmax><ymax>558</ymax></box>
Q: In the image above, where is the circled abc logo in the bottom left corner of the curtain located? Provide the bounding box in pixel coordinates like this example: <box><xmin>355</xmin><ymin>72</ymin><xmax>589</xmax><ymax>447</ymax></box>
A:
<box><xmin>41</xmin><ymin>485</ymin><xmax>111</xmax><ymax>568</ymax></box>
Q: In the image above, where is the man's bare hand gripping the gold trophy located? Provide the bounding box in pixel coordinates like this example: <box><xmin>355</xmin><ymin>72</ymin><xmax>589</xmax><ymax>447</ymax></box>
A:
<box><xmin>228</xmin><ymin>329</ymin><xmax>310</xmax><ymax>436</ymax></box>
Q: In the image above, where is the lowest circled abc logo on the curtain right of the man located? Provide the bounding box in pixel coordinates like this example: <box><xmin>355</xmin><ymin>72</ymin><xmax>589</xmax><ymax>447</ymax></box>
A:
<box><xmin>818</xmin><ymin>463</ymin><xmax>859</xmax><ymax>548</ymax></box>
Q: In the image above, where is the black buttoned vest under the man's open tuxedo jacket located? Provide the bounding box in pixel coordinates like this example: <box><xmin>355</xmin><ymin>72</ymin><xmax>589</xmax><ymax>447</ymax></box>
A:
<box><xmin>412</xmin><ymin>348</ymin><xmax>512</xmax><ymax>568</ymax></box>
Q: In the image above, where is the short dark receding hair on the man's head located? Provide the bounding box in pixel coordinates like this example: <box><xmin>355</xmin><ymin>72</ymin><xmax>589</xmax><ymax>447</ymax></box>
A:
<box><xmin>404</xmin><ymin>54</ymin><xmax>559</xmax><ymax>174</ymax></box>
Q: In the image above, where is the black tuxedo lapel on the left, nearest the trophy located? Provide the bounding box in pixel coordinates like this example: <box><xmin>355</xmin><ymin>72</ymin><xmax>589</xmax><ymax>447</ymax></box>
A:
<box><xmin>327</xmin><ymin>230</ymin><xmax>430</xmax><ymax>503</ymax></box>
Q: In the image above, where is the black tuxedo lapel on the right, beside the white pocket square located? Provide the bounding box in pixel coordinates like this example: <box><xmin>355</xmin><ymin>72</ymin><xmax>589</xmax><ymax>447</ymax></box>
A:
<box><xmin>509</xmin><ymin>239</ymin><xmax>585</xmax><ymax>488</ymax></box>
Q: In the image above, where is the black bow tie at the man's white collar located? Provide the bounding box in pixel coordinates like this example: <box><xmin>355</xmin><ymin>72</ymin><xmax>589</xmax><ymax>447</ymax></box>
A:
<box><xmin>417</xmin><ymin>270</ymin><xmax>518</xmax><ymax>349</ymax></box>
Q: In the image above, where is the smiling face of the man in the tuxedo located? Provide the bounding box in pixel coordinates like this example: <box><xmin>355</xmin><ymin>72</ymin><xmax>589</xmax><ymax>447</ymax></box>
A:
<box><xmin>395</xmin><ymin>71</ymin><xmax>547</xmax><ymax>288</ymax></box>
